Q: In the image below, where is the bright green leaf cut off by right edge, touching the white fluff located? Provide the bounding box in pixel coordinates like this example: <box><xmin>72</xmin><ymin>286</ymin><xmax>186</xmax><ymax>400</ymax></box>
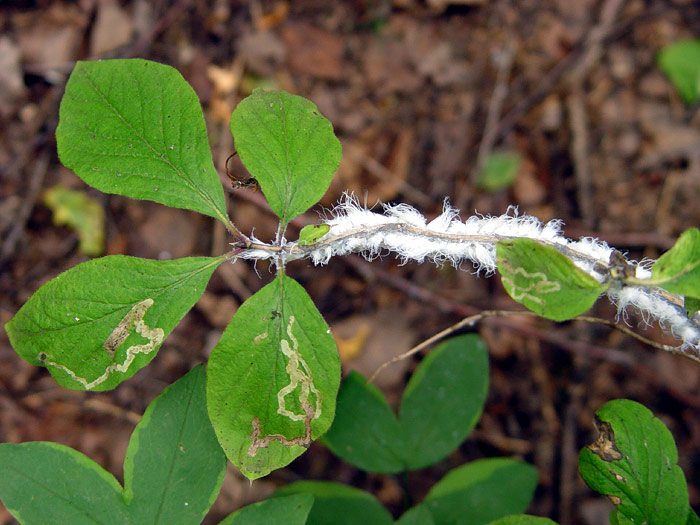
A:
<box><xmin>650</xmin><ymin>228</ymin><xmax>700</xmax><ymax>299</ymax></box>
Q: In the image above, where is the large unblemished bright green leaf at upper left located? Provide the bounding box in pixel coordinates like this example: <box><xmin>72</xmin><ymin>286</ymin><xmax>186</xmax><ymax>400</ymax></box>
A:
<box><xmin>56</xmin><ymin>59</ymin><xmax>230</xmax><ymax>224</ymax></box>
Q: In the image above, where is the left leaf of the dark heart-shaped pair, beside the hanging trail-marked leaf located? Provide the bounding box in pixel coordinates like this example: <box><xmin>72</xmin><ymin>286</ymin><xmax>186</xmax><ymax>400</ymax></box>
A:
<box><xmin>323</xmin><ymin>372</ymin><xmax>406</xmax><ymax>474</ymax></box>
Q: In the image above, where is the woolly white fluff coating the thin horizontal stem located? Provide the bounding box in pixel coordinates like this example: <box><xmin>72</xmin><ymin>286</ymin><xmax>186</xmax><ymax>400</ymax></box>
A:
<box><xmin>239</xmin><ymin>194</ymin><xmax>700</xmax><ymax>349</ymax></box>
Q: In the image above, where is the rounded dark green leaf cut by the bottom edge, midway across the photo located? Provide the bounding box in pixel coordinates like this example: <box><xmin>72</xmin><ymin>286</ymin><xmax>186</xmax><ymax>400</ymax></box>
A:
<box><xmin>273</xmin><ymin>481</ymin><xmax>394</xmax><ymax>525</ymax></box>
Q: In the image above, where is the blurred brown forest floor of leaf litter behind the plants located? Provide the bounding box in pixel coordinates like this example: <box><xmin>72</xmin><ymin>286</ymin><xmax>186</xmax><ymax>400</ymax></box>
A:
<box><xmin>0</xmin><ymin>0</ymin><xmax>700</xmax><ymax>524</ymax></box>
